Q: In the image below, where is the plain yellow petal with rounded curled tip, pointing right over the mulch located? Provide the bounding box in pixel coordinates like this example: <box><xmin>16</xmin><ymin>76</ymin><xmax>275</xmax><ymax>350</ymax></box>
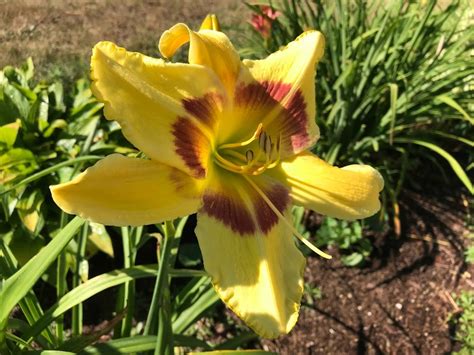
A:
<box><xmin>281</xmin><ymin>152</ymin><xmax>383</xmax><ymax>219</ymax></box>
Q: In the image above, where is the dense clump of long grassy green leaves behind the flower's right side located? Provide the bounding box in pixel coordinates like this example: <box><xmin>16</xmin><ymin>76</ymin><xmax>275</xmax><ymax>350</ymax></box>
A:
<box><xmin>242</xmin><ymin>0</ymin><xmax>474</xmax><ymax>233</ymax></box>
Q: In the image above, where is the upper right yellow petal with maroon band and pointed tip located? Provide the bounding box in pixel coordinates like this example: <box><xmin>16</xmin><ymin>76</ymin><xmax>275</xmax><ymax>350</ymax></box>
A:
<box><xmin>218</xmin><ymin>31</ymin><xmax>324</xmax><ymax>157</ymax></box>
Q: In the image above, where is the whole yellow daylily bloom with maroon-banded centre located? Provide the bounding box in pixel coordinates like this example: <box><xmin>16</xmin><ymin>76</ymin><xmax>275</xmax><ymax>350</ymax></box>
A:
<box><xmin>51</xmin><ymin>17</ymin><xmax>383</xmax><ymax>338</ymax></box>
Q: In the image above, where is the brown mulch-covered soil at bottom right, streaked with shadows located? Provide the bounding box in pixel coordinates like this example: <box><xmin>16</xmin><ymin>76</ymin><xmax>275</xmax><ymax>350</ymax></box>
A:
<box><xmin>262</xmin><ymin>184</ymin><xmax>474</xmax><ymax>355</ymax></box>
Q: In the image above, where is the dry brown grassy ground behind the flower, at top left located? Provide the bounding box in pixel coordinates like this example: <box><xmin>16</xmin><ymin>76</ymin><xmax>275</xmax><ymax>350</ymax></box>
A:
<box><xmin>0</xmin><ymin>0</ymin><xmax>247</xmax><ymax>77</ymax></box>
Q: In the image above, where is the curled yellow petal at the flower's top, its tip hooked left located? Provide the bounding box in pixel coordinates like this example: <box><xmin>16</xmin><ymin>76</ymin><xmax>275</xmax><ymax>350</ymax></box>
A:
<box><xmin>159</xmin><ymin>23</ymin><xmax>240</xmax><ymax>93</ymax></box>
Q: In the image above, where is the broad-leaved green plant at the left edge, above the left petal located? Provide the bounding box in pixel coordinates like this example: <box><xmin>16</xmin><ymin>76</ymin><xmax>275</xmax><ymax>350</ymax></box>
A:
<box><xmin>0</xmin><ymin>59</ymin><xmax>112</xmax><ymax>258</ymax></box>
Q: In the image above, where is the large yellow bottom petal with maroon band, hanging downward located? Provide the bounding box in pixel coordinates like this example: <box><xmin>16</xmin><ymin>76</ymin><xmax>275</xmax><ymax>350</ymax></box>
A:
<box><xmin>196</xmin><ymin>167</ymin><xmax>305</xmax><ymax>338</ymax></box>
